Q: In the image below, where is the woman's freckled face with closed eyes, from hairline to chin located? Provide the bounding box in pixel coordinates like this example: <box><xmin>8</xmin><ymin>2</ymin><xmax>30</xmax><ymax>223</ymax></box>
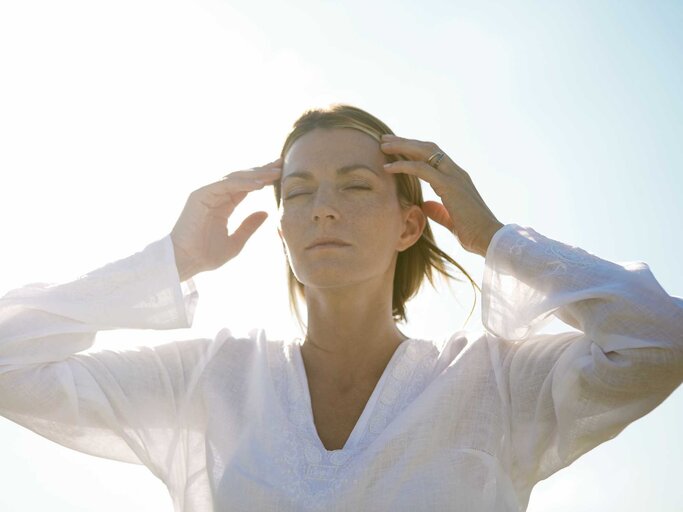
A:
<box><xmin>278</xmin><ymin>128</ymin><xmax>422</xmax><ymax>288</ymax></box>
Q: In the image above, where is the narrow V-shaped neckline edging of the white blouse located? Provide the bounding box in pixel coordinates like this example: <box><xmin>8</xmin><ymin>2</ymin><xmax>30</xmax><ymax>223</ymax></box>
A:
<box><xmin>294</xmin><ymin>338</ymin><xmax>413</xmax><ymax>454</ymax></box>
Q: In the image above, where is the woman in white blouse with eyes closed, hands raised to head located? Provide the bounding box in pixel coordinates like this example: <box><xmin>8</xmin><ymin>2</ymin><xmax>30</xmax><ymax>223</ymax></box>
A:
<box><xmin>0</xmin><ymin>105</ymin><xmax>683</xmax><ymax>512</ymax></box>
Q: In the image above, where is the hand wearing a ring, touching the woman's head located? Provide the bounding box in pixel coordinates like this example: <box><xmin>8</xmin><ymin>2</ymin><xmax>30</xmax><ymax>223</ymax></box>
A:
<box><xmin>381</xmin><ymin>135</ymin><xmax>504</xmax><ymax>257</ymax></box>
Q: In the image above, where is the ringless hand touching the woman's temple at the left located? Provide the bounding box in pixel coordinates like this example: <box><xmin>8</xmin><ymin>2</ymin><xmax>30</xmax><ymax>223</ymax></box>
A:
<box><xmin>171</xmin><ymin>158</ymin><xmax>282</xmax><ymax>281</ymax></box>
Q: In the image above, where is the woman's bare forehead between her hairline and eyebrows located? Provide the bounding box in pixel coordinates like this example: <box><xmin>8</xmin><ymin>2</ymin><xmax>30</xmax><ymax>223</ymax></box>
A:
<box><xmin>282</xmin><ymin>128</ymin><xmax>384</xmax><ymax>177</ymax></box>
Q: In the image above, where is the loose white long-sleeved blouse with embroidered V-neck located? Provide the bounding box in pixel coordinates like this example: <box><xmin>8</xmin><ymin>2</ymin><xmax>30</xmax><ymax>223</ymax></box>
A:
<box><xmin>0</xmin><ymin>224</ymin><xmax>683</xmax><ymax>512</ymax></box>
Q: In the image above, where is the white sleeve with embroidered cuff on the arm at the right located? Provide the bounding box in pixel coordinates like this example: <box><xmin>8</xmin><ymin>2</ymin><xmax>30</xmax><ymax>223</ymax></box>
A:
<box><xmin>482</xmin><ymin>224</ymin><xmax>683</xmax><ymax>485</ymax></box>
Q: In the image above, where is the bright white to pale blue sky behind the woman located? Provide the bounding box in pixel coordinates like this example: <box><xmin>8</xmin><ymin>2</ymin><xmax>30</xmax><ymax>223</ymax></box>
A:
<box><xmin>0</xmin><ymin>0</ymin><xmax>683</xmax><ymax>512</ymax></box>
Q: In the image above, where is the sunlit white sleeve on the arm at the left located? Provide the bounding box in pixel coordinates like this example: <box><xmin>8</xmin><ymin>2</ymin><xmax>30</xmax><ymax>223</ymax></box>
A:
<box><xmin>0</xmin><ymin>235</ymin><xmax>216</xmax><ymax>479</ymax></box>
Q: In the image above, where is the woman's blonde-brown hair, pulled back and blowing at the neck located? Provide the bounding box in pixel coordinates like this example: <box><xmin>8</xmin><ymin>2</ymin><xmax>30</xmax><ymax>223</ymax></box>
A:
<box><xmin>274</xmin><ymin>103</ymin><xmax>481</xmax><ymax>328</ymax></box>
